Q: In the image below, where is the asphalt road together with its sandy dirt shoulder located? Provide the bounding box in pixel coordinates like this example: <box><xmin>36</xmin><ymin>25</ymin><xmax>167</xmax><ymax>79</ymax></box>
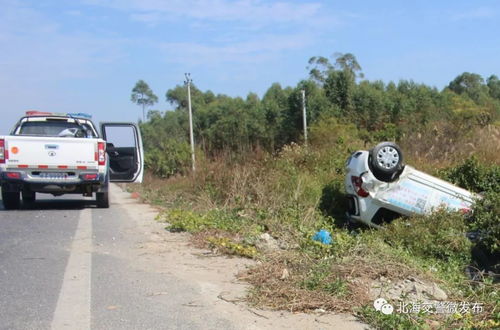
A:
<box><xmin>0</xmin><ymin>185</ymin><xmax>365</xmax><ymax>330</ymax></box>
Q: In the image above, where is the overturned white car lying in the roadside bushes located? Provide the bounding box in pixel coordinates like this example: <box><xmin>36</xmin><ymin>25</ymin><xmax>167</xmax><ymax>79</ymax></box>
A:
<box><xmin>345</xmin><ymin>142</ymin><xmax>479</xmax><ymax>227</ymax></box>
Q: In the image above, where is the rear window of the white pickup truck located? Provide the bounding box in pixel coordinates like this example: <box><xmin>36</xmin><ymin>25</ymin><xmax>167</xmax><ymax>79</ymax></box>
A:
<box><xmin>17</xmin><ymin>120</ymin><xmax>96</xmax><ymax>137</ymax></box>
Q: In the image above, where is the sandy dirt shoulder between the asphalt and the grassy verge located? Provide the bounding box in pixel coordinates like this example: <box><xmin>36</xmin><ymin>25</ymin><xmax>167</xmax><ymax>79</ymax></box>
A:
<box><xmin>111</xmin><ymin>185</ymin><xmax>368</xmax><ymax>330</ymax></box>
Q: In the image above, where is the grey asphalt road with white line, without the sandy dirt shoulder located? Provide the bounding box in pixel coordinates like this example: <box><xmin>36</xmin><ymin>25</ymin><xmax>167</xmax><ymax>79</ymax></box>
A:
<box><xmin>0</xmin><ymin>187</ymin><xmax>236</xmax><ymax>329</ymax></box>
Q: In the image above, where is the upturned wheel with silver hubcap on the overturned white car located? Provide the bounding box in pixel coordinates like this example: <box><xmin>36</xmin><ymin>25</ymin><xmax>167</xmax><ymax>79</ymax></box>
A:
<box><xmin>370</xmin><ymin>142</ymin><xmax>403</xmax><ymax>181</ymax></box>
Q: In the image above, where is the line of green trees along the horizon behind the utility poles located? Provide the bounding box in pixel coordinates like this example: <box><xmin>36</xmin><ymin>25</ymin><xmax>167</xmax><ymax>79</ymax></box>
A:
<box><xmin>131</xmin><ymin>53</ymin><xmax>500</xmax><ymax>176</ymax></box>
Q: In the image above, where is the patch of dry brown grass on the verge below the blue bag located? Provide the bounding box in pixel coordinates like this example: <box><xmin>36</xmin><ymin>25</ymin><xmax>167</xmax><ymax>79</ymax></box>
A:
<box><xmin>240</xmin><ymin>240</ymin><xmax>424</xmax><ymax>312</ymax></box>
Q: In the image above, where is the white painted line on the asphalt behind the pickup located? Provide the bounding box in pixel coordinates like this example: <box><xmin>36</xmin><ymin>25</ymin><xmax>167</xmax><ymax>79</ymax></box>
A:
<box><xmin>52</xmin><ymin>209</ymin><xmax>92</xmax><ymax>330</ymax></box>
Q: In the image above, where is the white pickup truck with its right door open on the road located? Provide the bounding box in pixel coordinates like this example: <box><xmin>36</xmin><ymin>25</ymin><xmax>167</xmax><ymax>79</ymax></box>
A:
<box><xmin>0</xmin><ymin>111</ymin><xmax>144</xmax><ymax>209</ymax></box>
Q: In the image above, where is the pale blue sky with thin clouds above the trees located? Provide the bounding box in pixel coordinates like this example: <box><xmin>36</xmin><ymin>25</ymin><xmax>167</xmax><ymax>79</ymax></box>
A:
<box><xmin>0</xmin><ymin>0</ymin><xmax>500</xmax><ymax>134</ymax></box>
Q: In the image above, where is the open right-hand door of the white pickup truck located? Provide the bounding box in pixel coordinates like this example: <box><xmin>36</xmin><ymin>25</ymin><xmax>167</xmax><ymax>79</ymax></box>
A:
<box><xmin>100</xmin><ymin>122</ymin><xmax>144</xmax><ymax>183</ymax></box>
